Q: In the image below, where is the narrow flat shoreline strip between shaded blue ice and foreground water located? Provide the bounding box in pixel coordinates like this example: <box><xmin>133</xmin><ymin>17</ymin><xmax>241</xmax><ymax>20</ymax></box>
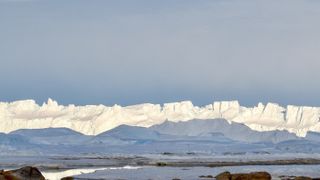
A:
<box><xmin>0</xmin><ymin>156</ymin><xmax>320</xmax><ymax>171</ymax></box>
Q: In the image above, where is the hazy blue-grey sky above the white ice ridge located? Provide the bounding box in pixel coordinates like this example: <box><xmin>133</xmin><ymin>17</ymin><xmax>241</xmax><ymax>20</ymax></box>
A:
<box><xmin>0</xmin><ymin>0</ymin><xmax>320</xmax><ymax>106</ymax></box>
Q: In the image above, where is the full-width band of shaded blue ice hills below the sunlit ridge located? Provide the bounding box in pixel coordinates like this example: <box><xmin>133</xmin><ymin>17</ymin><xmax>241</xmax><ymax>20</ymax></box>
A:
<box><xmin>0</xmin><ymin>119</ymin><xmax>320</xmax><ymax>156</ymax></box>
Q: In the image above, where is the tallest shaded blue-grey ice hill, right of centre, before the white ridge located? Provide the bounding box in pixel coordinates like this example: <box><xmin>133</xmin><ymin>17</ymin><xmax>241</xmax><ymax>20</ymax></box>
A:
<box><xmin>150</xmin><ymin>119</ymin><xmax>299</xmax><ymax>143</ymax></box>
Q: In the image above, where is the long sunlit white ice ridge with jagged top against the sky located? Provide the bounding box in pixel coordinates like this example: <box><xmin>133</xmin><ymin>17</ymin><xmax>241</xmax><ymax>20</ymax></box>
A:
<box><xmin>0</xmin><ymin>99</ymin><xmax>320</xmax><ymax>137</ymax></box>
